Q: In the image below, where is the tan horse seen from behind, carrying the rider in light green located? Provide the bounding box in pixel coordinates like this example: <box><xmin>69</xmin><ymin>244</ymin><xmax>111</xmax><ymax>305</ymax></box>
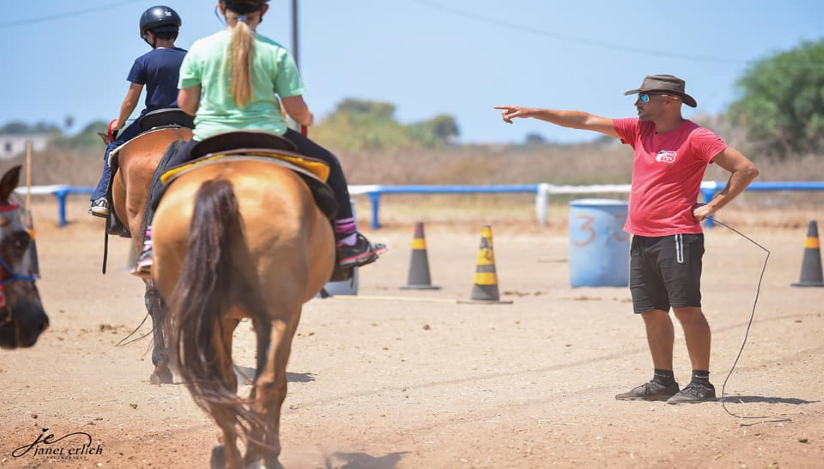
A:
<box><xmin>152</xmin><ymin>160</ymin><xmax>335</xmax><ymax>468</ymax></box>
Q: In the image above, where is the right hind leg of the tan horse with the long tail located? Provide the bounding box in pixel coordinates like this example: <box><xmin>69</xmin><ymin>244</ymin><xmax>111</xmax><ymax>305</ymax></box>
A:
<box><xmin>246</xmin><ymin>312</ymin><xmax>300</xmax><ymax>469</ymax></box>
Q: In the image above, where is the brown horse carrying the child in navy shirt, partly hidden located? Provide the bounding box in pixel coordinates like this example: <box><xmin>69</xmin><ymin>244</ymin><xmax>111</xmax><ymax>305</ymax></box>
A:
<box><xmin>112</xmin><ymin>127</ymin><xmax>192</xmax><ymax>384</ymax></box>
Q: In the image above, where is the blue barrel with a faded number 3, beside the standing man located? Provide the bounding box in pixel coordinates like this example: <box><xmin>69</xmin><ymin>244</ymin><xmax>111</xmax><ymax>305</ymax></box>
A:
<box><xmin>569</xmin><ymin>199</ymin><xmax>630</xmax><ymax>287</ymax></box>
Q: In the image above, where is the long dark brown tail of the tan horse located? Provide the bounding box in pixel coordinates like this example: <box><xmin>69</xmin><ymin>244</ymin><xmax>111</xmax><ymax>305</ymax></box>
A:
<box><xmin>163</xmin><ymin>179</ymin><xmax>268</xmax><ymax>446</ymax></box>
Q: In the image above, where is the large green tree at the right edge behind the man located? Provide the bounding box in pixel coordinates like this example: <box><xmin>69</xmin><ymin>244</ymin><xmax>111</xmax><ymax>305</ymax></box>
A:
<box><xmin>730</xmin><ymin>40</ymin><xmax>824</xmax><ymax>158</ymax></box>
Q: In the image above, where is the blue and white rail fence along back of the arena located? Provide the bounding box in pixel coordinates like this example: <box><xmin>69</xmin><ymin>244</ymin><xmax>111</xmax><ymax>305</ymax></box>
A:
<box><xmin>16</xmin><ymin>181</ymin><xmax>824</xmax><ymax>229</ymax></box>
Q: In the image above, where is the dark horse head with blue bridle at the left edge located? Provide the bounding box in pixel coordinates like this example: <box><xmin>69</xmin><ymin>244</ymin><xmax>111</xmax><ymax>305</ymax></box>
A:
<box><xmin>0</xmin><ymin>165</ymin><xmax>49</xmax><ymax>349</ymax></box>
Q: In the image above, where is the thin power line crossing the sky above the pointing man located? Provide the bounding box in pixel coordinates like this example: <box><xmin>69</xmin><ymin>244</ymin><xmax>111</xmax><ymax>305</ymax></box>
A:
<box><xmin>412</xmin><ymin>0</ymin><xmax>748</xmax><ymax>64</ymax></box>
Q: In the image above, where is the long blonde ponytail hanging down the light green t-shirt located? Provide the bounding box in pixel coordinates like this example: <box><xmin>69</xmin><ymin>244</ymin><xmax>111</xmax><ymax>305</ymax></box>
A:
<box><xmin>226</xmin><ymin>11</ymin><xmax>260</xmax><ymax>108</ymax></box>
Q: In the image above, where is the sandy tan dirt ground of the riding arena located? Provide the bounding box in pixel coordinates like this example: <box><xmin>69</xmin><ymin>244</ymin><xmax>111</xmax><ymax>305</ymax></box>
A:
<box><xmin>0</xmin><ymin>200</ymin><xmax>824</xmax><ymax>469</ymax></box>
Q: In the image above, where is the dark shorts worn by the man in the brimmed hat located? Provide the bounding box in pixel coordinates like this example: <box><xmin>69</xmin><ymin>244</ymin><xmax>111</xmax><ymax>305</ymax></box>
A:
<box><xmin>629</xmin><ymin>234</ymin><xmax>704</xmax><ymax>313</ymax></box>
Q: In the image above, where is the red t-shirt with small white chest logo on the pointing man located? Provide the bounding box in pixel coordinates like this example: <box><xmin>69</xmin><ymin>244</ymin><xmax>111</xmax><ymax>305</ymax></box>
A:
<box><xmin>613</xmin><ymin>118</ymin><xmax>727</xmax><ymax>237</ymax></box>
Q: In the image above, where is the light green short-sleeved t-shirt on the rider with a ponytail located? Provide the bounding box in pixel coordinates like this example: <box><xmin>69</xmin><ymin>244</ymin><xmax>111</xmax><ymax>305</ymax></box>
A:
<box><xmin>178</xmin><ymin>30</ymin><xmax>303</xmax><ymax>140</ymax></box>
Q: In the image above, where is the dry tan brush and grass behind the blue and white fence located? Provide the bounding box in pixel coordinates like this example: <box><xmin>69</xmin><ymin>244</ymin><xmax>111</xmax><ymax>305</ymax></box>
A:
<box><xmin>0</xmin><ymin>141</ymin><xmax>824</xmax><ymax>228</ymax></box>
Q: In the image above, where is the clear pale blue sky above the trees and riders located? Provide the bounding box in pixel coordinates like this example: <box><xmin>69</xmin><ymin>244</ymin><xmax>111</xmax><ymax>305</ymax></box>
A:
<box><xmin>0</xmin><ymin>0</ymin><xmax>824</xmax><ymax>142</ymax></box>
